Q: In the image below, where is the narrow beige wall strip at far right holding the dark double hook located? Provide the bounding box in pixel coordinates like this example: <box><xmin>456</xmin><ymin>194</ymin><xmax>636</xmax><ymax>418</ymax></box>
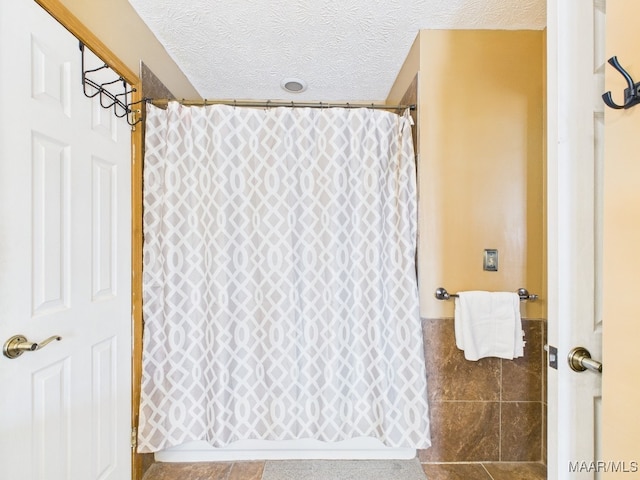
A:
<box><xmin>602</xmin><ymin>0</ymin><xmax>640</xmax><ymax>468</ymax></box>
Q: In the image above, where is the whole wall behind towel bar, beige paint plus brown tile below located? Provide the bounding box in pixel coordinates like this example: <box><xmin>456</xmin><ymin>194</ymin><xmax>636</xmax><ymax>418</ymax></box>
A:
<box><xmin>387</xmin><ymin>30</ymin><xmax>546</xmax><ymax>462</ymax></box>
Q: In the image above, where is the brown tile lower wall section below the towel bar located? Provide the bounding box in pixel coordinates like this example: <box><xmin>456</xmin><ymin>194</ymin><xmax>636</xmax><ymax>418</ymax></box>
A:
<box><xmin>419</xmin><ymin>318</ymin><xmax>546</xmax><ymax>462</ymax></box>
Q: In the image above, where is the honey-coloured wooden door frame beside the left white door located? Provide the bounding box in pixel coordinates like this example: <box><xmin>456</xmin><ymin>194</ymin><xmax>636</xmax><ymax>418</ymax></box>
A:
<box><xmin>34</xmin><ymin>0</ymin><xmax>144</xmax><ymax>480</ymax></box>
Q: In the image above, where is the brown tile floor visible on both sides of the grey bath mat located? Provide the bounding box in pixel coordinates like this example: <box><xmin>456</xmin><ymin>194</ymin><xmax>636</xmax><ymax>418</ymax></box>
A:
<box><xmin>143</xmin><ymin>462</ymin><xmax>547</xmax><ymax>480</ymax></box>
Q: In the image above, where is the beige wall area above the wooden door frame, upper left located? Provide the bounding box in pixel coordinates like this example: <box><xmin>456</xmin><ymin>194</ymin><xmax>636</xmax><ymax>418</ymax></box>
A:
<box><xmin>60</xmin><ymin>0</ymin><xmax>200</xmax><ymax>99</ymax></box>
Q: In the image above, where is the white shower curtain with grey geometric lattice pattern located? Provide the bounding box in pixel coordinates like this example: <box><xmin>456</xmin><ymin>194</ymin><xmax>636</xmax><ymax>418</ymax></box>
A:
<box><xmin>138</xmin><ymin>102</ymin><xmax>430</xmax><ymax>452</ymax></box>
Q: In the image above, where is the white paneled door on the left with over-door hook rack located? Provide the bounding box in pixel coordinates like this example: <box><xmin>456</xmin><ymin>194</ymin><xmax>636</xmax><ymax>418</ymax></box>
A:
<box><xmin>0</xmin><ymin>0</ymin><xmax>131</xmax><ymax>480</ymax></box>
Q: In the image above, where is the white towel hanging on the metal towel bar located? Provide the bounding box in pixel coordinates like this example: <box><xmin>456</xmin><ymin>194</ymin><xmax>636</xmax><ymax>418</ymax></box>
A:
<box><xmin>454</xmin><ymin>291</ymin><xmax>525</xmax><ymax>361</ymax></box>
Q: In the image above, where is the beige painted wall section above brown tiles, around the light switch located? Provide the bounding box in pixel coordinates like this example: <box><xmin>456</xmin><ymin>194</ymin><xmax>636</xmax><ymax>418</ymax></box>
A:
<box><xmin>388</xmin><ymin>30</ymin><xmax>546</xmax><ymax>318</ymax></box>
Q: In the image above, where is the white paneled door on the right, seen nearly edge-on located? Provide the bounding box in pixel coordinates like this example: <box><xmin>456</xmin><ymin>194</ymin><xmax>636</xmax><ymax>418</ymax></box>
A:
<box><xmin>547</xmin><ymin>0</ymin><xmax>606</xmax><ymax>480</ymax></box>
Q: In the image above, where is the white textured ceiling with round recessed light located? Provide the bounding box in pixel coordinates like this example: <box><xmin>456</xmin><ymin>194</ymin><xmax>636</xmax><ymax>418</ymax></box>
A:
<box><xmin>129</xmin><ymin>0</ymin><xmax>546</xmax><ymax>102</ymax></box>
